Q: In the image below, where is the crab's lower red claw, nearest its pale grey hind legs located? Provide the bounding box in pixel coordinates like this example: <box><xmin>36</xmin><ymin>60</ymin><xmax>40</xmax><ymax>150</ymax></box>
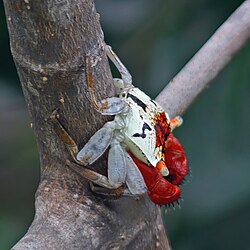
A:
<box><xmin>130</xmin><ymin>154</ymin><xmax>181</xmax><ymax>205</ymax></box>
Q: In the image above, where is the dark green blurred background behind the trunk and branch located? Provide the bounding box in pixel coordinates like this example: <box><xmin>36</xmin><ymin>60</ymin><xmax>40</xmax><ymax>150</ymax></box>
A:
<box><xmin>0</xmin><ymin>0</ymin><xmax>250</xmax><ymax>250</ymax></box>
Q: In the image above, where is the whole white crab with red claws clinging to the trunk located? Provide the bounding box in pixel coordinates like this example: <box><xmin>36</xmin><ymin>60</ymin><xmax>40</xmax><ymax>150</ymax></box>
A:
<box><xmin>51</xmin><ymin>45</ymin><xmax>188</xmax><ymax>205</ymax></box>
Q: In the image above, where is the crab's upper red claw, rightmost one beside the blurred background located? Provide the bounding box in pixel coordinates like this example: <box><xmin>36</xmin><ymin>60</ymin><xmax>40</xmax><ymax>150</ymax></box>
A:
<box><xmin>164</xmin><ymin>134</ymin><xmax>188</xmax><ymax>185</ymax></box>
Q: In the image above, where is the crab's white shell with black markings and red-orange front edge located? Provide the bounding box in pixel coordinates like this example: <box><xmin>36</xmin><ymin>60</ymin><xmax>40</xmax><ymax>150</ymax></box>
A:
<box><xmin>120</xmin><ymin>88</ymin><xmax>170</xmax><ymax>167</ymax></box>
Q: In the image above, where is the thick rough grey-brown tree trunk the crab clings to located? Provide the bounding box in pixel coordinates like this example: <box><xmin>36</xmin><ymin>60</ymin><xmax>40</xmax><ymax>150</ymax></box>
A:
<box><xmin>4</xmin><ymin>0</ymin><xmax>170</xmax><ymax>250</ymax></box>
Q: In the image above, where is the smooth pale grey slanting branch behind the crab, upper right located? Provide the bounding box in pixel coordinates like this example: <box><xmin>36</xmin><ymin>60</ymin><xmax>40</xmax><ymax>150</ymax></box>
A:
<box><xmin>156</xmin><ymin>0</ymin><xmax>250</xmax><ymax>117</ymax></box>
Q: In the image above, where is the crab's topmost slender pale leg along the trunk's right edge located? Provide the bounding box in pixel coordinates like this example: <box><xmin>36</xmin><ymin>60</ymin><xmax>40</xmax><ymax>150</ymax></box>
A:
<box><xmin>105</xmin><ymin>45</ymin><xmax>132</xmax><ymax>87</ymax></box>
